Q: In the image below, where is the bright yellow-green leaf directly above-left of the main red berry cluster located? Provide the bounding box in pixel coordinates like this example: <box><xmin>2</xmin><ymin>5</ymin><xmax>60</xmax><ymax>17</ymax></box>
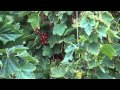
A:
<box><xmin>28</xmin><ymin>13</ymin><xmax>41</xmax><ymax>29</ymax></box>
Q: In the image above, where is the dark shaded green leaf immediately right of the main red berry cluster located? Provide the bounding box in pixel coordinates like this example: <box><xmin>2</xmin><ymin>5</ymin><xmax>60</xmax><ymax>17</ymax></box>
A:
<box><xmin>48</xmin><ymin>35</ymin><xmax>61</xmax><ymax>48</ymax></box>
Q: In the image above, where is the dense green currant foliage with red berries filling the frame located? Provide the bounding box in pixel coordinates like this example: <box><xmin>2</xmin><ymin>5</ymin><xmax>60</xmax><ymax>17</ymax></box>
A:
<box><xmin>0</xmin><ymin>11</ymin><xmax>120</xmax><ymax>79</ymax></box>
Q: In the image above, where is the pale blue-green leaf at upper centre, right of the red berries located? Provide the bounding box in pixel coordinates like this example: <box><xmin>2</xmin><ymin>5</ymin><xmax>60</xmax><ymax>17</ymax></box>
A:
<box><xmin>53</xmin><ymin>23</ymin><xmax>67</xmax><ymax>36</ymax></box>
